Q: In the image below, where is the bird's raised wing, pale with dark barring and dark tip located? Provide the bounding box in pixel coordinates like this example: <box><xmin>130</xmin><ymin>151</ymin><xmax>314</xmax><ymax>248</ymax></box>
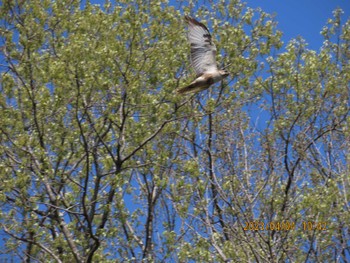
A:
<box><xmin>185</xmin><ymin>16</ymin><xmax>218</xmax><ymax>77</ymax></box>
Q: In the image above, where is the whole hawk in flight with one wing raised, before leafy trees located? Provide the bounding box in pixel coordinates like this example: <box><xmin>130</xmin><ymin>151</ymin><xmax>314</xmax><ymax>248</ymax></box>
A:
<box><xmin>177</xmin><ymin>16</ymin><xmax>229</xmax><ymax>94</ymax></box>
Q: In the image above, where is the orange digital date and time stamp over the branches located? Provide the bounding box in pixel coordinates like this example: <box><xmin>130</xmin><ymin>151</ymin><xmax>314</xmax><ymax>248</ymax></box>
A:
<box><xmin>243</xmin><ymin>221</ymin><xmax>327</xmax><ymax>231</ymax></box>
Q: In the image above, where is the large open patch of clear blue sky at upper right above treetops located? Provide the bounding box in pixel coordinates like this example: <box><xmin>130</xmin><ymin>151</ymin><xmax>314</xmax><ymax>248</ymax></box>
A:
<box><xmin>244</xmin><ymin>0</ymin><xmax>350</xmax><ymax>50</ymax></box>
